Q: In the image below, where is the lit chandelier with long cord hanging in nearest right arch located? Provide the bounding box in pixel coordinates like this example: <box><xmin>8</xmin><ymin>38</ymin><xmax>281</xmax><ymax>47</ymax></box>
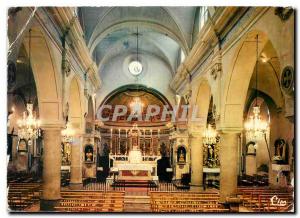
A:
<box><xmin>245</xmin><ymin>35</ymin><xmax>269</xmax><ymax>141</ymax></box>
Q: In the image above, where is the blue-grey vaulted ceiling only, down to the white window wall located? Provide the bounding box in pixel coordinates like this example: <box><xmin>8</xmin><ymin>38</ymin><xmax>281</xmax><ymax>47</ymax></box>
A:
<box><xmin>78</xmin><ymin>7</ymin><xmax>196</xmax><ymax>73</ymax></box>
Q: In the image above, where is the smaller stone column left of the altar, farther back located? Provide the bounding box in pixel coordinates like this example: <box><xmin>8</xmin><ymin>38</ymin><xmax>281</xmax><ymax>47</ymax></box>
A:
<box><xmin>70</xmin><ymin>136</ymin><xmax>82</xmax><ymax>189</ymax></box>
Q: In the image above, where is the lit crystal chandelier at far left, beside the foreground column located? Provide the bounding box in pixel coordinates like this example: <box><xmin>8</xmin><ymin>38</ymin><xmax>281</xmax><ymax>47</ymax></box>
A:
<box><xmin>17</xmin><ymin>103</ymin><xmax>41</xmax><ymax>141</ymax></box>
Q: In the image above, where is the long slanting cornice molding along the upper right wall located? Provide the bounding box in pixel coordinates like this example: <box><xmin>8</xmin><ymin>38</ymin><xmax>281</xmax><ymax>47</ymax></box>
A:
<box><xmin>170</xmin><ymin>7</ymin><xmax>268</xmax><ymax>92</ymax></box>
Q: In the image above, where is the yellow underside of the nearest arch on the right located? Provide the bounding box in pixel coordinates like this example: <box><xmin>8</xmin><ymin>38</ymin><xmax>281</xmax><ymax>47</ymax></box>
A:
<box><xmin>221</xmin><ymin>30</ymin><xmax>280</xmax><ymax>130</ymax></box>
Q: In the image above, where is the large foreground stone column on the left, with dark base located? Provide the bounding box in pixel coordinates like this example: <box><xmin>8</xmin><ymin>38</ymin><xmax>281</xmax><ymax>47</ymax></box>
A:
<box><xmin>40</xmin><ymin>127</ymin><xmax>61</xmax><ymax>211</ymax></box>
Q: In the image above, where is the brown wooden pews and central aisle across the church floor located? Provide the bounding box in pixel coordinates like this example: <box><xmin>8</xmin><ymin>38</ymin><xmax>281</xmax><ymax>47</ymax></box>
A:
<box><xmin>8</xmin><ymin>171</ymin><xmax>294</xmax><ymax>213</ymax></box>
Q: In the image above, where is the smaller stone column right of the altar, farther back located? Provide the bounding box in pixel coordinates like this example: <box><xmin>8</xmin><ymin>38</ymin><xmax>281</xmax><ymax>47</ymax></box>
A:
<box><xmin>190</xmin><ymin>133</ymin><xmax>203</xmax><ymax>187</ymax></box>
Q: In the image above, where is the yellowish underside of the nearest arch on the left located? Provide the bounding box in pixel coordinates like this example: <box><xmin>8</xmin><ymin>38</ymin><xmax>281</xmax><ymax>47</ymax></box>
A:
<box><xmin>24</xmin><ymin>26</ymin><xmax>63</xmax><ymax>126</ymax></box>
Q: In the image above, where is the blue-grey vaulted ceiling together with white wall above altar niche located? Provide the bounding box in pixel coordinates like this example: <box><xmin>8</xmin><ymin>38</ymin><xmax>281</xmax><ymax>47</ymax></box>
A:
<box><xmin>77</xmin><ymin>7</ymin><xmax>197</xmax><ymax>107</ymax></box>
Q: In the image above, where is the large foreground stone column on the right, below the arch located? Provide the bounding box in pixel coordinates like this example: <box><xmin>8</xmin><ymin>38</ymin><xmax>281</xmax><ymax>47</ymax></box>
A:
<box><xmin>220</xmin><ymin>132</ymin><xmax>239</xmax><ymax>203</ymax></box>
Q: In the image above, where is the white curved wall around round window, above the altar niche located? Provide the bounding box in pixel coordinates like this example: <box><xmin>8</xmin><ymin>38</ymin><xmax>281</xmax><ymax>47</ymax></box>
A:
<box><xmin>97</xmin><ymin>54</ymin><xmax>175</xmax><ymax>107</ymax></box>
